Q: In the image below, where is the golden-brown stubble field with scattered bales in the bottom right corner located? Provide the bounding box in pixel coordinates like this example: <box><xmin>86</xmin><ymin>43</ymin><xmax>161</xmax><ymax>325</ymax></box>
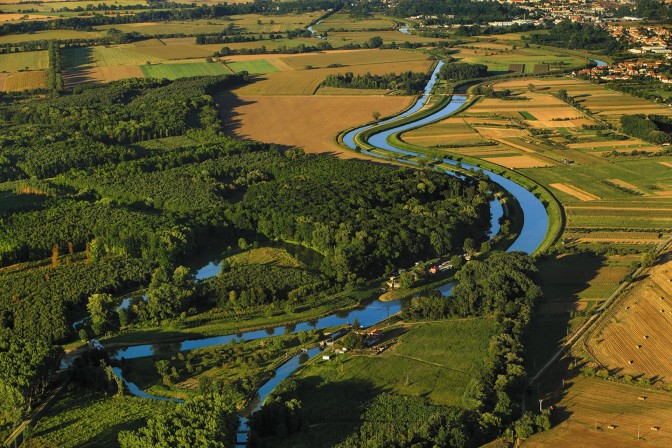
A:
<box><xmin>522</xmin><ymin>376</ymin><xmax>672</xmax><ymax>448</ymax></box>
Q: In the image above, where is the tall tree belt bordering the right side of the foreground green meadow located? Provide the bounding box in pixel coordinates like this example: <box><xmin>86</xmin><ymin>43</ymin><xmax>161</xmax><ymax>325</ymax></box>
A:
<box><xmin>396</xmin><ymin>252</ymin><xmax>550</xmax><ymax>446</ymax></box>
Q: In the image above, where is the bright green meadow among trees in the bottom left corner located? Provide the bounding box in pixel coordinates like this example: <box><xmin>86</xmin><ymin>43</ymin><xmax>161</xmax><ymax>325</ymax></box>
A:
<box><xmin>31</xmin><ymin>389</ymin><xmax>174</xmax><ymax>448</ymax></box>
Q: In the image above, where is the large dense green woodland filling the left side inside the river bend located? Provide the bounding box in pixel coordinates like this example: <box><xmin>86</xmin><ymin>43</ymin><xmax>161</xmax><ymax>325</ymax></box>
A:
<box><xmin>0</xmin><ymin>75</ymin><xmax>491</xmax><ymax>434</ymax></box>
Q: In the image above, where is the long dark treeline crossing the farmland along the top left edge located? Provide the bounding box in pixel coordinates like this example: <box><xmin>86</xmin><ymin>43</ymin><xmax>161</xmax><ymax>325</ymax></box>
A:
<box><xmin>0</xmin><ymin>0</ymin><xmax>341</xmax><ymax>36</ymax></box>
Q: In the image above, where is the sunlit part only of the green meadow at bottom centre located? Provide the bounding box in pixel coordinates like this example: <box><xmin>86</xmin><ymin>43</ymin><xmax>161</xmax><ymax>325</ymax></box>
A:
<box><xmin>297</xmin><ymin>319</ymin><xmax>495</xmax><ymax>406</ymax></box>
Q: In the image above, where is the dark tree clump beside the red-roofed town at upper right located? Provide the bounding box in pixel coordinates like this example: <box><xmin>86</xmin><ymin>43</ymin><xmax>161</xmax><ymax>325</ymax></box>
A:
<box><xmin>529</xmin><ymin>20</ymin><xmax>624</xmax><ymax>53</ymax></box>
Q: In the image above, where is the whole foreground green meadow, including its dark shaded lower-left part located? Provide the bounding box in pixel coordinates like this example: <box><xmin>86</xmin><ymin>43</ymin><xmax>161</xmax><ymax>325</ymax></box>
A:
<box><xmin>266</xmin><ymin>319</ymin><xmax>495</xmax><ymax>448</ymax></box>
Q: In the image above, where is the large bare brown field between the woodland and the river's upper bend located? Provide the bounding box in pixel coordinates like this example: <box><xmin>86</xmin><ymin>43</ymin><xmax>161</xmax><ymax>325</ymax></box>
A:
<box><xmin>218</xmin><ymin>94</ymin><xmax>412</xmax><ymax>158</ymax></box>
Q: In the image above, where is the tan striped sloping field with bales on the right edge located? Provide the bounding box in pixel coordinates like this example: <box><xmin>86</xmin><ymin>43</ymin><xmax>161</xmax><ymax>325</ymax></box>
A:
<box><xmin>588</xmin><ymin>253</ymin><xmax>672</xmax><ymax>383</ymax></box>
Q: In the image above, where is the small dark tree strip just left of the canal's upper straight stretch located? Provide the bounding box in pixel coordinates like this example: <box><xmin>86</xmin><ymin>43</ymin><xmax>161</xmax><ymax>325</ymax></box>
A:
<box><xmin>322</xmin><ymin>71</ymin><xmax>429</xmax><ymax>95</ymax></box>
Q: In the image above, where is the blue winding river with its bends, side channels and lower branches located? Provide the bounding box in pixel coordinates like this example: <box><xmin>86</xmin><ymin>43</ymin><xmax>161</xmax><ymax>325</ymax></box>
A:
<box><xmin>101</xmin><ymin>61</ymin><xmax>552</xmax><ymax>447</ymax></box>
